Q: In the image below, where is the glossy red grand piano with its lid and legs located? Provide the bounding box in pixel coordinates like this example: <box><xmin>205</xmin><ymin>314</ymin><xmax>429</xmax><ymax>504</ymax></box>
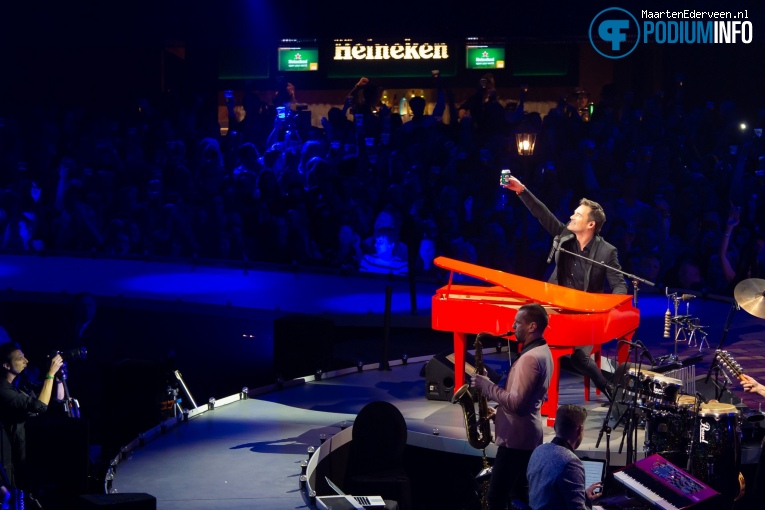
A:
<box><xmin>432</xmin><ymin>257</ymin><xmax>640</xmax><ymax>427</ymax></box>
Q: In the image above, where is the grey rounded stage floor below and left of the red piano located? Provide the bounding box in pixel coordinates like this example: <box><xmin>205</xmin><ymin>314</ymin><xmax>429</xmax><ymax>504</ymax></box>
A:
<box><xmin>113</xmin><ymin>353</ymin><xmax>759</xmax><ymax>510</ymax></box>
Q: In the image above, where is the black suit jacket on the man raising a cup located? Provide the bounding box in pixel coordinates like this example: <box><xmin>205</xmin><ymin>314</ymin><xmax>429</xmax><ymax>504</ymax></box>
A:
<box><xmin>518</xmin><ymin>189</ymin><xmax>627</xmax><ymax>294</ymax></box>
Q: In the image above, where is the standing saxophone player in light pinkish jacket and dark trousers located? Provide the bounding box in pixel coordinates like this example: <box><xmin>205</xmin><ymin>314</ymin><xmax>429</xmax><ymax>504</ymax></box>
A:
<box><xmin>471</xmin><ymin>304</ymin><xmax>553</xmax><ymax>510</ymax></box>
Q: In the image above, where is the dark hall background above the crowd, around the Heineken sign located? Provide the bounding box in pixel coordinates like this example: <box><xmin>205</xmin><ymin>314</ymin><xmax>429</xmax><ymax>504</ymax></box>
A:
<box><xmin>0</xmin><ymin>0</ymin><xmax>765</xmax><ymax>111</ymax></box>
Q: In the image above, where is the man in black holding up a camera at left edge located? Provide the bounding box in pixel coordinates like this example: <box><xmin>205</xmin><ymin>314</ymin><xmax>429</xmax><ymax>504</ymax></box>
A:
<box><xmin>0</xmin><ymin>342</ymin><xmax>64</xmax><ymax>488</ymax></box>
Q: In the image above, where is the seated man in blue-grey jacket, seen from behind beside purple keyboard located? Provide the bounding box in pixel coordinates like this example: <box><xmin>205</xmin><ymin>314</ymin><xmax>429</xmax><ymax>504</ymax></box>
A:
<box><xmin>526</xmin><ymin>404</ymin><xmax>603</xmax><ymax>510</ymax></box>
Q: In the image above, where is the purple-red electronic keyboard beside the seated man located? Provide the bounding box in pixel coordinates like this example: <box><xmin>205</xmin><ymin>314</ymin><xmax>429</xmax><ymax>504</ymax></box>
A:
<box><xmin>614</xmin><ymin>455</ymin><xmax>717</xmax><ymax>510</ymax></box>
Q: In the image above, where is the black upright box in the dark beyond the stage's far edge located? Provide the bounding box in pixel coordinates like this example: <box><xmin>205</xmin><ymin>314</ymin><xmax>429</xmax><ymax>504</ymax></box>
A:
<box><xmin>274</xmin><ymin>315</ymin><xmax>335</xmax><ymax>380</ymax></box>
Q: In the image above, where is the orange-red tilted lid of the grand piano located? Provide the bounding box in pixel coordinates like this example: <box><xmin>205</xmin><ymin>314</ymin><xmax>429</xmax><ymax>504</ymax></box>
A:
<box><xmin>433</xmin><ymin>257</ymin><xmax>632</xmax><ymax>313</ymax></box>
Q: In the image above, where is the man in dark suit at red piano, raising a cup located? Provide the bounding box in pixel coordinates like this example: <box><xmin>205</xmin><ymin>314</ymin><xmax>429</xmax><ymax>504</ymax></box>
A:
<box><xmin>504</xmin><ymin>177</ymin><xmax>627</xmax><ymax>400</ymax></box>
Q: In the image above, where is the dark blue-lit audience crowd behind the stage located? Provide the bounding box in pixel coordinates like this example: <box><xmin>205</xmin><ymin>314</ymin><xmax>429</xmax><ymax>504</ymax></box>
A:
<box><xmin>0</xmin><ymin>77</ymin><xmax>765</xmax><ymax>295</ymax></box>
